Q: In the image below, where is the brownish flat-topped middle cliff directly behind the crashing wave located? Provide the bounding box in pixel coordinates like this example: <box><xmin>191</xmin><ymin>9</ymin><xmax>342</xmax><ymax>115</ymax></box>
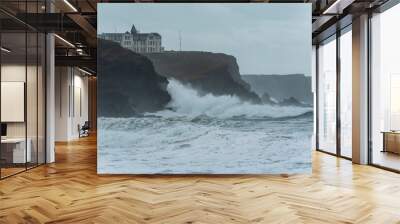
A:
<box><xmin>145</xmin><ymin>51</ymin><xmax>261</xmax><ymax>103</ymax></box>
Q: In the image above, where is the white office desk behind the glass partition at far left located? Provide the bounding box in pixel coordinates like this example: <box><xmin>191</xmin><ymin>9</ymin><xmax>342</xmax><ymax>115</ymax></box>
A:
<box><xmin>1</xmin><ymin>138</ymin><xmax>32</xmax><ymax>163</ymax></box>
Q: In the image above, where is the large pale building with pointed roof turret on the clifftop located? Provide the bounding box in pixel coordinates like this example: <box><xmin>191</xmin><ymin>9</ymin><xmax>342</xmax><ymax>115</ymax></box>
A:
<box><xmin>100</xmin><ymin>25</ymin><xmax>164</xmax><ymax>53</ymax></box>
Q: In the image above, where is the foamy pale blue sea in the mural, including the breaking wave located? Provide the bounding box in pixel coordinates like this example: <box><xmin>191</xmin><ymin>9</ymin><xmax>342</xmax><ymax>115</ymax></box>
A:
<box><xmin>97</xmin><ymin>80</ymin><xmax>313</xmax><ymax>174</ymax></box>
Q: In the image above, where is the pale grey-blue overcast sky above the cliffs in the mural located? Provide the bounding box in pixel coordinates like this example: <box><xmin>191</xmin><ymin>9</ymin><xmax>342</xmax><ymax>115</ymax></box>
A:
<box><xmin>98</xmin><ymin>3</ymin><xmax>311</xmax><ymax>75</ymax></box>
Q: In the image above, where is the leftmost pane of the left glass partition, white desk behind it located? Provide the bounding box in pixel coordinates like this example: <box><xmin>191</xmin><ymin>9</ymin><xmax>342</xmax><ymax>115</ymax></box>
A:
<box><xmin>0</xmin><ymin>32</ymin><xmax>27</xmax><ymax>177</ymax></box>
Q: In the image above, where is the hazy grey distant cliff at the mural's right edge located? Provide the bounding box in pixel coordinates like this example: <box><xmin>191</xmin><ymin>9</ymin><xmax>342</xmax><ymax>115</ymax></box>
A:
<box><xmin>242</xmin><ymin>74</ymin><xmax>313</xmax><ymax>104</ymax></box>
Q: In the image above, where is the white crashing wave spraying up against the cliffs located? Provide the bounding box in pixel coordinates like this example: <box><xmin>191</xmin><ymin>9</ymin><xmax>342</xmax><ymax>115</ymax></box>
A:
<box><xmin>150</xmin><ymin>79</ymin><xmax>312</xmax><ymax>119</ymax></box>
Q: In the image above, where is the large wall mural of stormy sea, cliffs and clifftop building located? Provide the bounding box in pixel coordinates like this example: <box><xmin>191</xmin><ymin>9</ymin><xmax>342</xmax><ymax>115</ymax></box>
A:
<box><xmin>97</xmin><ymin>3</ymin><xmax>313</xmax><ymax>174</ymax></box>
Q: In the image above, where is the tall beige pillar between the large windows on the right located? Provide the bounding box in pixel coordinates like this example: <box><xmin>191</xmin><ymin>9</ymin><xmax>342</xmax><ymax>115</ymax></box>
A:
<box><xmin>352</xmin><ymin>15</ymin><xmax>368</xmax><ymax>164</ymax></box>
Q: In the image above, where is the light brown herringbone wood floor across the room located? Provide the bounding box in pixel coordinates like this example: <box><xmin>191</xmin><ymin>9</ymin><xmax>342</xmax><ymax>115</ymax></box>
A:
<box><xmin>0</xmin><ymin>137</ymin><xmax>400</xmax><ymax>224</ymax></box>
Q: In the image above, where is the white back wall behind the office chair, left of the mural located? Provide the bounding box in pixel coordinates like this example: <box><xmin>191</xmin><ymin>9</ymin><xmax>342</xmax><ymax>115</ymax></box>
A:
<box><xmin>55</xmin><ymin>67</ymin><xmax>88</xmax><ymax>141</ymax></box>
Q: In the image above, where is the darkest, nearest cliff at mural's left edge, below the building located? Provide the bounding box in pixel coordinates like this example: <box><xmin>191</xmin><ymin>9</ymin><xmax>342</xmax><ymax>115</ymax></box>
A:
<box><xmin>98</xmin><ymin>39</ymin><xmax>171</xmax><ymax>117</ymax></box>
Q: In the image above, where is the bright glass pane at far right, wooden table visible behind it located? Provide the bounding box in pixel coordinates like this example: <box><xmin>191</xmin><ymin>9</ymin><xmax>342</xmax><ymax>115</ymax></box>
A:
<box><xmin>370</xmin><ymin>5</ymin><xmax>400</xmax><ymax>170</ymax></box>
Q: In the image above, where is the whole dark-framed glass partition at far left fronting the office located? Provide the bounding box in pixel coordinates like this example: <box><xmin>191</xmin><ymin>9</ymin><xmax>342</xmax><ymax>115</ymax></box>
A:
<box><xmin>0</xmin><ymin>1</ymin><xmax>46</xmax><ymax>178</ymax></box>
